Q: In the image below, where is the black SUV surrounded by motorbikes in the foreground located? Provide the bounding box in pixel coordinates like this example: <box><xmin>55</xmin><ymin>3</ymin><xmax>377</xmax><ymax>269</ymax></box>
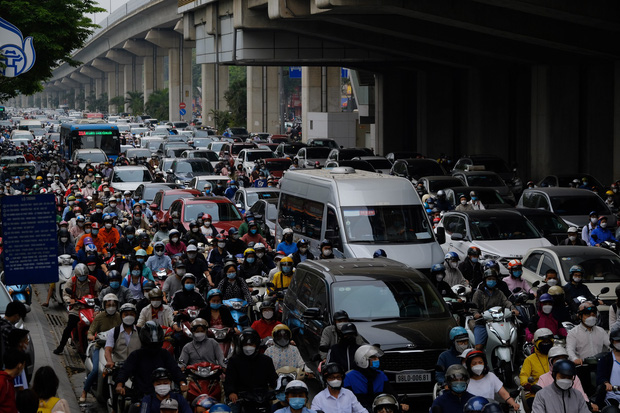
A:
<box><xmin>282</xmin><ymin>258</ymin><xmax>456</xmax><ymax>396</ymax></box>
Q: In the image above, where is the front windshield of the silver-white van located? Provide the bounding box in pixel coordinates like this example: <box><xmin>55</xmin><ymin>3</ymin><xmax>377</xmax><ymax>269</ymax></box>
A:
<box><xmin>342</xmin><ymin>205</ymin><xmax>433</xmax><ymax>244</ymax></box>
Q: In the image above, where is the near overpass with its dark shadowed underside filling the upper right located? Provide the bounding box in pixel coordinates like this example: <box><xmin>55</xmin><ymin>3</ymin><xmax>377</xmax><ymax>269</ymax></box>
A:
<box><xmin>183</xmin><ymin>0</ymin><xmax>620</xmax><ymax>182</ymax></box>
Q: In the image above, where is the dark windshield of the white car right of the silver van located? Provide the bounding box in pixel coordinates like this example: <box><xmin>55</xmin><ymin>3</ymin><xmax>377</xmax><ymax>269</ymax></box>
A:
<box><xmin>469</xmin><ymin>215</ymin><xmax>540</xmax><ymax>241</ymax></box>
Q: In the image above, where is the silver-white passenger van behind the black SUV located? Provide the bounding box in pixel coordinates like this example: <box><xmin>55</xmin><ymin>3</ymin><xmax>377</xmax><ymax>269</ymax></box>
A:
<box><xmin>276</xmin><ymin>167</ymin><xmax>444</xmax><ymax>273</ymax></box>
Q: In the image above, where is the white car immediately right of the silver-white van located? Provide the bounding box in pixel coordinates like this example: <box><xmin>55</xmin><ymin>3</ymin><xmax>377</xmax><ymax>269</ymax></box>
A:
<box><xmin>437</xmin><ymin>209</ymin><xmax>552</xmax><ymax>274</ymax></box>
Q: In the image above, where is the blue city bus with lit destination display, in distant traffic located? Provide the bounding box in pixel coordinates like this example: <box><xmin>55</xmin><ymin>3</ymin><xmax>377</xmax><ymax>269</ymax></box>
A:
<box><xmin>60</xmin><ymin>123</ymin><xmax>121</xmax><ymax>159</ymax></box>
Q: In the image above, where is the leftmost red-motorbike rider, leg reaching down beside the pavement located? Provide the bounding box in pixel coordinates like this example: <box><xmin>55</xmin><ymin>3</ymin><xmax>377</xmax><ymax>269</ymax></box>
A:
<box><xmin>54</xmin><ymin>264</ymin><xmax>101</xmax><ymax>354</ymax></box>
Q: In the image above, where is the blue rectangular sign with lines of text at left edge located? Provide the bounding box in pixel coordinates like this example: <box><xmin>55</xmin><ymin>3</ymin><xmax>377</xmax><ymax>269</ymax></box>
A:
<box><xmin>2</xmin><ymin>194</ymin><xmax>58</xmax><ymax>285</ymax></box>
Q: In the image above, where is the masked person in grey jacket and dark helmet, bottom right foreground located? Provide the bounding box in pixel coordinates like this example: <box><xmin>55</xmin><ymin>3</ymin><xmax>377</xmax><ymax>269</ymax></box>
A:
<box><xmin>532</xmin><ymin>360</ymin><xmax>588</xmax><ymax>413</ymax></box>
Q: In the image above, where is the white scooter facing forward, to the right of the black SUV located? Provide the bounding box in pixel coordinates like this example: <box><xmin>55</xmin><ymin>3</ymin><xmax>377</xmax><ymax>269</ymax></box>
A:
<box><xmin>465</xmin><ymin>306</ymin><xmax>517</xmax><ymax>383</ymax></box>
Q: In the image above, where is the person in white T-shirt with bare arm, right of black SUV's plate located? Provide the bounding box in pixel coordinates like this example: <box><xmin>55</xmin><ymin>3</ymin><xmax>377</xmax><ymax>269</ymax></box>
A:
<box><xmin>465</xmin><ymin>350</ymin><xmax>520</xmax><ymax>411</ymax></box>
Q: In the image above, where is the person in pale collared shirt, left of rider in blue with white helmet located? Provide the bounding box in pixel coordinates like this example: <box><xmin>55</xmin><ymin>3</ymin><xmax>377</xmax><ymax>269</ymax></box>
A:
<box><xmin>312</xmin><ymin>363</ymin><xmax>366</xmax><ymax>413</ymax></box>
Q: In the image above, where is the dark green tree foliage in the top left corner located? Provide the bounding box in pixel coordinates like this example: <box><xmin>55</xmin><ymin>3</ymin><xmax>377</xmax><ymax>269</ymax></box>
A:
<box><xmin>0</xmin><ymin>0</ymin><xmax>105</xmax><ymax>102</ymax></box>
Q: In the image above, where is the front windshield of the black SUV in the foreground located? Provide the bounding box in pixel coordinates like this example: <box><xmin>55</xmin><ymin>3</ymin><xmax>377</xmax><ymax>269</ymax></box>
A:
<box><xmin>331</xmin><ymin>278</ymin><xmax>447</xmax><ymax>321</ymax></box>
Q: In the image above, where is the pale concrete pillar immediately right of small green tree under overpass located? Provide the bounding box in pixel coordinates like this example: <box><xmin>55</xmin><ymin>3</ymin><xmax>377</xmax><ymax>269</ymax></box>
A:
<box><xmin>247</xmin><ymin>66</ymin><xmax>280</xmax><ymax>134</ymax></box>
